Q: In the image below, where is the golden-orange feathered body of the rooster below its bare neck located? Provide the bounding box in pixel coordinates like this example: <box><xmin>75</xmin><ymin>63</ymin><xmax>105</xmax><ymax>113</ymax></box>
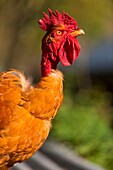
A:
<box><xmin>0</xmin><ymin>70</ymin><xmax>63</xmax><ymax>166</ymax></box>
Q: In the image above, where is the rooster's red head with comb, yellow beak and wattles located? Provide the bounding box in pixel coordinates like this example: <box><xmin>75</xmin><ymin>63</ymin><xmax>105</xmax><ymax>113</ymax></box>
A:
<box><xmin>38</xmin><ymin>9</ymin><xmax>84</xmax><ymax>75</ymax></box>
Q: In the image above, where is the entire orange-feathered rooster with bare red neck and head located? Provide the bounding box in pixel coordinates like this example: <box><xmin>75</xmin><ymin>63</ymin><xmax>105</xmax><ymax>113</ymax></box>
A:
<box><xmin>0</xmin><ymin>9</ymin><xmax>84</xmax><ymax>170</ymax></box>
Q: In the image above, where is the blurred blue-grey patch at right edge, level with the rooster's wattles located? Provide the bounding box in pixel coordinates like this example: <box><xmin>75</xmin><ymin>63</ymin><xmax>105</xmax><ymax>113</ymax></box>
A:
<box><xmin>90</xmin><ymin>39</ymin><xmax>113</xmax><ymax>74</ymax></box>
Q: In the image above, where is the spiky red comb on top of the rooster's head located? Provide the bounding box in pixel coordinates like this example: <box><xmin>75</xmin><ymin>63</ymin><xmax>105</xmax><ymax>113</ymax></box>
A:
<box><xmin>38</xmin><ymin>8</ymin><xmax>78</xmax><ymax>31</ymax></box>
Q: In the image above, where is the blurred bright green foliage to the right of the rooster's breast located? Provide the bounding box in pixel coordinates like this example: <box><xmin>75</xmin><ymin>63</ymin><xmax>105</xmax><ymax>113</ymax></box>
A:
<box><xmin>50</xmin><ymin>84</ymin><xmax>113</xmax><ymax>170</ymax></box>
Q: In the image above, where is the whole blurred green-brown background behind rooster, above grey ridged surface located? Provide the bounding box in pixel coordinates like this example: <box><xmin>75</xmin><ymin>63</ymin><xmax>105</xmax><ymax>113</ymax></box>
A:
<box><xmin>0</xmin><ymin>0</ymin><xmax>113</xmax><ymax>170</ymax></box>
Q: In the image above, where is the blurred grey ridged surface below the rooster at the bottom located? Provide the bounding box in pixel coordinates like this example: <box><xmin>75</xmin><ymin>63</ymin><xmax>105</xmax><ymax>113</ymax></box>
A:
<box><xmin>12</xmin><ymin>142</ymin><xmax>105</xmax><ymax>170</ymax></box>
